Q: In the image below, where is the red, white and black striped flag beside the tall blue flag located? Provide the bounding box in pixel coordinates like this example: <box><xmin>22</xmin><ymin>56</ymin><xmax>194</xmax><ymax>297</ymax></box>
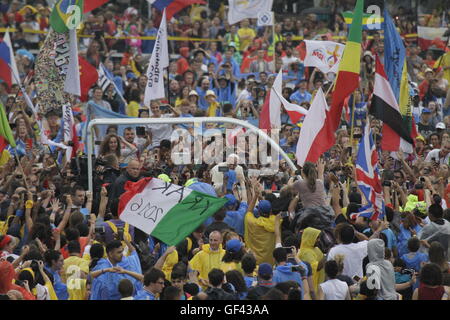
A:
<box><xmin>370</xmin><ymin>56</ymin><xmax>413</xmax><ymax>153</ymax></box>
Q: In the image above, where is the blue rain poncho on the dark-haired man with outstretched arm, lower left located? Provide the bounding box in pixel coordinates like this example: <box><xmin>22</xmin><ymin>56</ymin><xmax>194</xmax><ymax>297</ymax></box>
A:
<box><xmin>90</xmin><ymin>251</ymin><xmax>143</xmax><ymax>300</ymax></box>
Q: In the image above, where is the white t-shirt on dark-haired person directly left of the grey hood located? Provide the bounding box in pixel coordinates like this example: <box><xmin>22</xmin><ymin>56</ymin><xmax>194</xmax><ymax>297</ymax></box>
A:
<box><xmin>327</xmin><ymin>240</ymin><xmax>368</xmax><ymax>278</ymax></box>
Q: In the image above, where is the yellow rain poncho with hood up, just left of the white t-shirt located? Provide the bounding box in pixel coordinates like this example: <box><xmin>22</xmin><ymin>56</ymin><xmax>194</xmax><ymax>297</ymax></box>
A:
<box><xmin>298</xmin><ymin>228</ymin><xmax>325</xmax><ymax>292</ymax></box>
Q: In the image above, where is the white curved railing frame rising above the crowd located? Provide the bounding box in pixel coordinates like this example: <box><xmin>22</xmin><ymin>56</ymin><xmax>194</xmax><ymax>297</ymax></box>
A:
<box><xmin>87</xmin><ymin>117</ymin><xmax>297</xmax><ymax>192</ymax></box>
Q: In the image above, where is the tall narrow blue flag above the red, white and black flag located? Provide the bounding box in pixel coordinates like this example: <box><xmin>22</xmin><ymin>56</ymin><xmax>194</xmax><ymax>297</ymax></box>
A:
<box><xmin>384</xmin><ymin>9</ymin><xmax>406</xmax><ymax>102</ymax></box>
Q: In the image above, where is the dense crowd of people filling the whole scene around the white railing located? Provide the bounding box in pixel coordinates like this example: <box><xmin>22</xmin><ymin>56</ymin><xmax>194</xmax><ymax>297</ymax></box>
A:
<box><xmin>0</xmin><ymin>0</ymin><xmax>450</xmax><ymax>300</ymax></box>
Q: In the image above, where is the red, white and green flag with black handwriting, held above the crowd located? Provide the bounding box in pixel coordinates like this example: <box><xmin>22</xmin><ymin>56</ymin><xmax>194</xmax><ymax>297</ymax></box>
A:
<box><xmin>119</xmin><ymin>178</ymin><xmax>227</xmax><ymax>245</ymax></box>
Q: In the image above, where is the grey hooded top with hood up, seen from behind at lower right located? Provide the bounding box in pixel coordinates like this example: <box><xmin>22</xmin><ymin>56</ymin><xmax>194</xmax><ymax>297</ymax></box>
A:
<box><xmin>366</xmin><ymin>239</ymin><xmax>398</xmax><ymax>300</ymax></box>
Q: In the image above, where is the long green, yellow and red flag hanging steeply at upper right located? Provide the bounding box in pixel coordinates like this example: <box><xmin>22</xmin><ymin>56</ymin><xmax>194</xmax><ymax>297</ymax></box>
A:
<box><xmin>314</xmin><ymin>0</ymin><xmax>364</xmax><ymax>159</ymax></box>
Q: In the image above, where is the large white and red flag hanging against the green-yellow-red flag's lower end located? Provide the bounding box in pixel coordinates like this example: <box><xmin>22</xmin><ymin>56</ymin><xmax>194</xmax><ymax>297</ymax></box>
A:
<box><xmin>296</xmin><ymin>88</ymin><xmax>328</xmax><ymax>166</ymax></box>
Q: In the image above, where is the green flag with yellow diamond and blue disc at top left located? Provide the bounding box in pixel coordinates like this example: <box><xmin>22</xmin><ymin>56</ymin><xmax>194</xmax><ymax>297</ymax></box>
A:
<box><xmin>50</xmin><ymin>0</ymin><xmax>83</xmax><ymax>33</ymax></box>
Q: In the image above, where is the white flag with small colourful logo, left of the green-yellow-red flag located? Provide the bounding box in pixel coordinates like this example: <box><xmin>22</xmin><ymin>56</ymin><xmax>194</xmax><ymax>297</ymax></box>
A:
<box><xmin>303</xmin><ymin>40</ymin><xmax>345</xmax><ymax>74</ymax></box>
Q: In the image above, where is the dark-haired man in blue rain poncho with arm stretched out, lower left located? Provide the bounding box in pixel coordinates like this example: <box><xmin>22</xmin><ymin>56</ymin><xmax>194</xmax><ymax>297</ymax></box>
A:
<box><xmin>91</xmin><ymin>240</ymin><xmax>143</xmax><ymax>300</ymax></box>
